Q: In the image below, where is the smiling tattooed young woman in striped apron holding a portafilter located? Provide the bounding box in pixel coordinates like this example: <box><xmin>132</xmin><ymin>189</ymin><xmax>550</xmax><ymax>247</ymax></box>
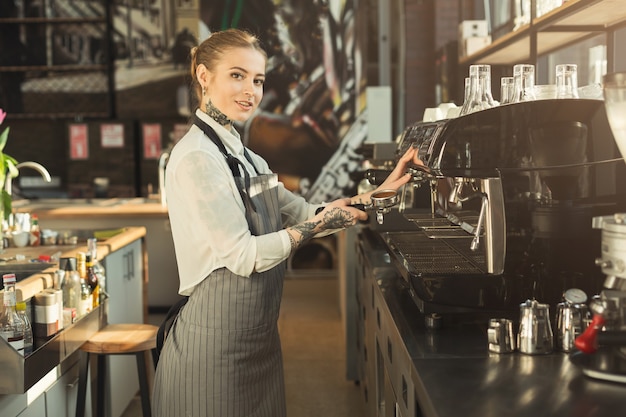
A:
<box><xmin>152</xmin><ymin>29</ymin><xmax>415</xmax><ymax>417</ymax></box>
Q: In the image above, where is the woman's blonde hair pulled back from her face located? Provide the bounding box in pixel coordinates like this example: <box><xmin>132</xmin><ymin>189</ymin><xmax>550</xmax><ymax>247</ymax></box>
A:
<box><xmin>190</xmin><ymin>28</ymin><xmax>267</xmax><ymax>103</ymax></box>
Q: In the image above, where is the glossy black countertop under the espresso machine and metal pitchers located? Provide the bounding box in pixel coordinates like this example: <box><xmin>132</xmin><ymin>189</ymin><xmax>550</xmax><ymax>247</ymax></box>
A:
<box><xmin>358</xmin><ymin>228</ymin><xmax>626</xmax><ymax>417</ymax></box>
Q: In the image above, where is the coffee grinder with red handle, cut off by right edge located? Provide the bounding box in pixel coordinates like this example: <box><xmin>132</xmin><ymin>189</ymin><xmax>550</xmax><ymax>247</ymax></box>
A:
<box><xmin>570</xmin><ymin>73</ymin><xmax>626</xmax><ymax>383</ymax></box>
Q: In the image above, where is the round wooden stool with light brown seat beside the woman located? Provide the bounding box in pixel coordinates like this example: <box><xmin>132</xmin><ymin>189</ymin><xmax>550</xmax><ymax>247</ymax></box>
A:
<box><xmin>76</xmin><ymin>323</ymin><xmax>159</xmax><ymax>417</ymax></box>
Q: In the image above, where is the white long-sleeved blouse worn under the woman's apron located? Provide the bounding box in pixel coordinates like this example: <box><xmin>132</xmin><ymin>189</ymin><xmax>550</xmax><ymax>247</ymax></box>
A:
<box><xmin>165</xmin><ymin>110</ymin><xmax>319</xmax><ymax>295</ymax></box>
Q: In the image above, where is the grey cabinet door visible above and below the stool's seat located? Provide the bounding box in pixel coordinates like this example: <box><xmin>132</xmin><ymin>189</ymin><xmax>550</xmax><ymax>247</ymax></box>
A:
<box><xmin>104</xmin><ymin>239</ymin><xmax>144</xmax><ymax>417</ymax></box>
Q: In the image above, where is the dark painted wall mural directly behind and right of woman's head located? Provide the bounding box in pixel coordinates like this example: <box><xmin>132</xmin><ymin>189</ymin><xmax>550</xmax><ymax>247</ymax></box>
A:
<box><xmin>200</xmin><ymin>0</ymin><xmax>366</xmax><ymax>201</ymax></box>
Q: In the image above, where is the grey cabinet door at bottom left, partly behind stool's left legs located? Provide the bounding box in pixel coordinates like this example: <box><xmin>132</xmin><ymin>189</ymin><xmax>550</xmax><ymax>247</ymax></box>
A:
<box><xmin>46</xmin><ymin>362</ymin><xmax>91</xmax><ymax>417</ymax></box>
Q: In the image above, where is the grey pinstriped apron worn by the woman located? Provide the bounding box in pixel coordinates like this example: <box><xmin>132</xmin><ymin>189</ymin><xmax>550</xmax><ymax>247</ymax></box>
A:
<box><xmin>152</xmin><ymin>120</ymin><xmax>286</xmax><ymax>417</ymax></box>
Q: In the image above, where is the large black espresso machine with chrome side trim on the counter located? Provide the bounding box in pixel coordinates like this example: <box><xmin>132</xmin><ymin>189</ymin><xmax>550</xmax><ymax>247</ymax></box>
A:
<box><xmin>379</xmin><ymin>99</ymin><xmax>626</xmax><ymax>317</ymax></box>
